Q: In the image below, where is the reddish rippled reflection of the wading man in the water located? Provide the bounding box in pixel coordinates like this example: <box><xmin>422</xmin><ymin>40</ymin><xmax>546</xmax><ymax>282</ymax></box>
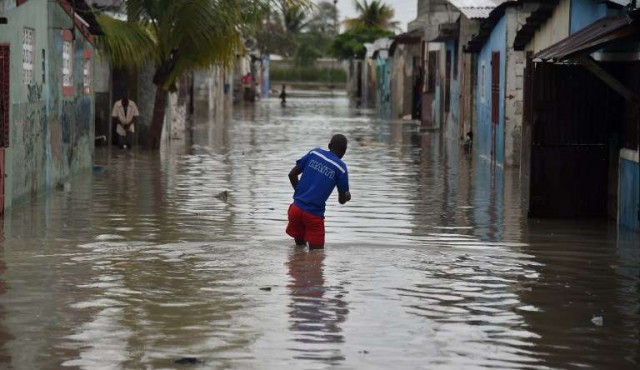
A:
<box><xmin>288</xmin><ymin>247</ymin><xmax>349</xmax><ymax>364</ymax></box>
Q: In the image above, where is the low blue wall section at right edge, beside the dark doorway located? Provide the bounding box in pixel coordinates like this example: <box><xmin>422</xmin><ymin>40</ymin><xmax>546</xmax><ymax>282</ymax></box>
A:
<box><xmin>618</xmin><ymin>159</ymin><xmax>640</xmax><ymax>230</ymax></box>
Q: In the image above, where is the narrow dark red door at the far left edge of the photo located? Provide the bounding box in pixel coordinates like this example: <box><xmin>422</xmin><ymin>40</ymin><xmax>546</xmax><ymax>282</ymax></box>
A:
<box><xmin>0</xmin><ymin>45</ymin><xmax>9</xmax><ymax>216</ymax></box>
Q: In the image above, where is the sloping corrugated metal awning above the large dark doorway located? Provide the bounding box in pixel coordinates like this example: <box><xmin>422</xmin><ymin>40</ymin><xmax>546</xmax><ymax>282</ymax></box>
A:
<box><xmin>534</xmin><ymin>15</ymin><xmax>637</xmax><ymax>62</ymax></box>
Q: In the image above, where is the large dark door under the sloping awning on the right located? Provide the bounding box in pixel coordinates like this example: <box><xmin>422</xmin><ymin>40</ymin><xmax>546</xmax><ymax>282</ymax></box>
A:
<box><xmin>527</xmin><ymin>63</ymin><xmax>622</xmax><ymax>218</ymax></box>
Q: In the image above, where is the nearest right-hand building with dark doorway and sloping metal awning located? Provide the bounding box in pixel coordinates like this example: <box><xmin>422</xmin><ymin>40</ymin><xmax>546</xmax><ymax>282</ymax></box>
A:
<box><xmin>514</xmin><ymin>0</ymin><xmax>640</xmax><ymax>230</ymax></box>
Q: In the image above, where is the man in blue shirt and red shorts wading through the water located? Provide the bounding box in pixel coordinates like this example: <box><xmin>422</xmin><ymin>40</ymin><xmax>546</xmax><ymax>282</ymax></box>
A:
<box><xmin>286</xmin><ymin>134</ymin><xmax>351</xmax><ymax>249</ymax></box>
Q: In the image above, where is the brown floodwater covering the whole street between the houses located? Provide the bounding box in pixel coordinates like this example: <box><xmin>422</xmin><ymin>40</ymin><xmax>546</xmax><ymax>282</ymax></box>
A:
<box><xmin>0</xmin><ymin>97</ymin><xmax>640</xmax><ymax>369</ymax></box>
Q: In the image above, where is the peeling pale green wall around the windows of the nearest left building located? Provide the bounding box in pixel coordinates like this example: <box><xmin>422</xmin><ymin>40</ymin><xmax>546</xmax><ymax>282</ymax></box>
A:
<box><xmin>0</xmin><ymin>0</ymin><xmax>94</xmax><ymax>207</ymax></box>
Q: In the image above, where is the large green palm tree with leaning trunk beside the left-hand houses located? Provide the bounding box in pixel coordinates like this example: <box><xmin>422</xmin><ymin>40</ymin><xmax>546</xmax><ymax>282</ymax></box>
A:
<box><xmin>98</xmin><ymin>0</ymin><xmax>306</xmax><ymax>149</ymax></box>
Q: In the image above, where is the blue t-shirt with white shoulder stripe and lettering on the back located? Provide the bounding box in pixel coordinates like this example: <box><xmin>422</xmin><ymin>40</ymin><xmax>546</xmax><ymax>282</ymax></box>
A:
<box><xmin>293</xmin><ymin>148</ymin><xmax>349</xmax><ymax>217</ymax></box>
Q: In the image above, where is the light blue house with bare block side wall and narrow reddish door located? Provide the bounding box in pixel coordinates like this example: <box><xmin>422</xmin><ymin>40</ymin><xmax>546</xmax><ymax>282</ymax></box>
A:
<box><xmin>466</xmin><ymin>1</ymin><xmax>535</xmax><ymax>167</ymax></box>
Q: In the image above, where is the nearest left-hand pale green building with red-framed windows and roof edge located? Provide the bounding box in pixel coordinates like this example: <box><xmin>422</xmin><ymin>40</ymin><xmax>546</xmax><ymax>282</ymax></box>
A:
<box><xmin>0</xmin><ymin>0</ymin><xmax>101</xmax><ymax>210</ymax></box>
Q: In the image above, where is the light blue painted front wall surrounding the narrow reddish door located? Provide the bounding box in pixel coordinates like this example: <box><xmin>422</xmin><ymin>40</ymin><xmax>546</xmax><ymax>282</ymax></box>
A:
<box><xmin>473</xmin><ymin>15</ymin><xmax>507</xmax><ymax>164</ymax></box>
